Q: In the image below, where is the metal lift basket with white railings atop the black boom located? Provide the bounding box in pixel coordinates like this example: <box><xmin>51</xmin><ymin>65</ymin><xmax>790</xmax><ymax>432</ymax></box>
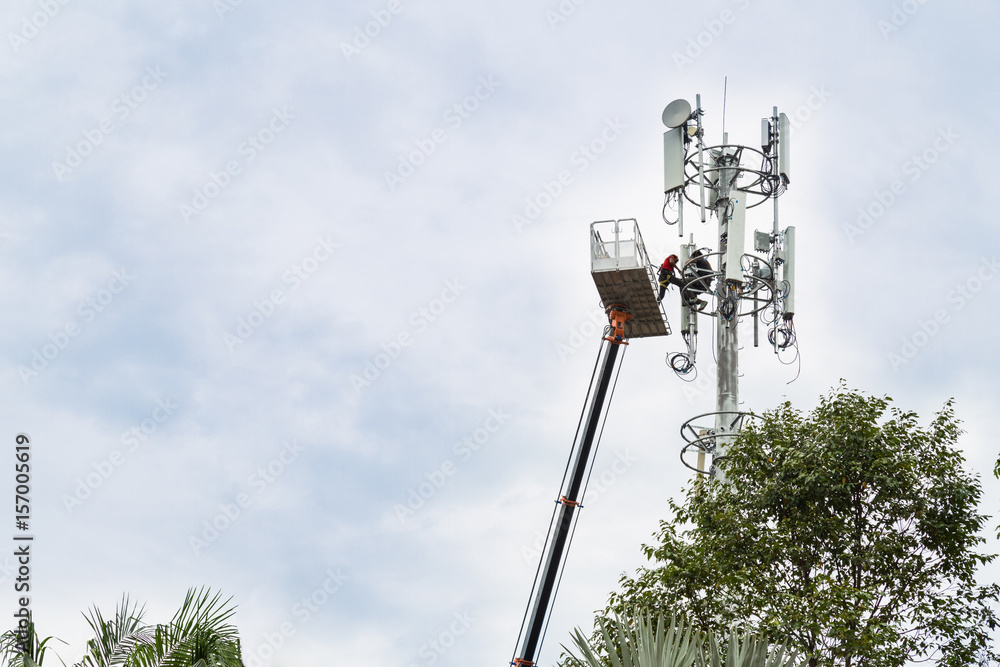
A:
<box><xmin>590</xmin><ymin>218</ymin><xmax>670</xmax><ymax>338</ymax></box>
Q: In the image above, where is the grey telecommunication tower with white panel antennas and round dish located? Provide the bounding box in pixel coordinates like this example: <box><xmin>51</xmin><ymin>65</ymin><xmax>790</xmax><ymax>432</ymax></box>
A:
<box><xmin>663</xmin><ymin>95</ymin><xmax>798</xmax><ymax>476</ymax></box>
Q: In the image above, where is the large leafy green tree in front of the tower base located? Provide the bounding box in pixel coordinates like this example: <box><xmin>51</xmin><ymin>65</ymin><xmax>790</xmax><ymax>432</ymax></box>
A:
<box><xmin>595</xmin><ymin>386</ymin><xmax>1000</xmax><ymax>667</ymax></box>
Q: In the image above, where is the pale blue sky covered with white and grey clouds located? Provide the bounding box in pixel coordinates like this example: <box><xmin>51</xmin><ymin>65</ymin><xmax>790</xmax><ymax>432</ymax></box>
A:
<box><xmin>0</xmin><ymin>0</ymin><xmax>1000</xmax><ymax>667</ymax></box>
